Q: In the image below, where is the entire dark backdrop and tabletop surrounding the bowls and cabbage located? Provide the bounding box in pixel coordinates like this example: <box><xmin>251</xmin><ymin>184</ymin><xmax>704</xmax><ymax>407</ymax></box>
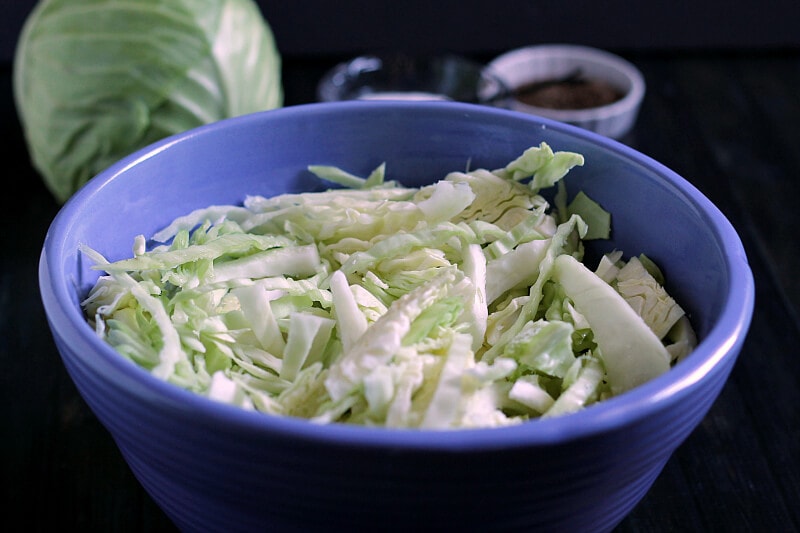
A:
<box><xmin>0</xmin><ymin>0</ymin><xmax>800</xmax><ymax>533</ymax></box>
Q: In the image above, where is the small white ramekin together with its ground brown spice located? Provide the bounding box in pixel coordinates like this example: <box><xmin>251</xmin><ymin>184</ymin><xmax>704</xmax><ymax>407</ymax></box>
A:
<box><xmin>486</xmin><ymin>44</ymin><xmax>646</xmax><ymax>139</ymax></box>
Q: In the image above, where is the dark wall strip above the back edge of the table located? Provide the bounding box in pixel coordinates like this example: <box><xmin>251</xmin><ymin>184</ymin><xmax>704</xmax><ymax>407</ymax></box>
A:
<box><xmin>0</xmin><ymin>0</ymin><xmax>800</xmax><ymax>61</ymax></box>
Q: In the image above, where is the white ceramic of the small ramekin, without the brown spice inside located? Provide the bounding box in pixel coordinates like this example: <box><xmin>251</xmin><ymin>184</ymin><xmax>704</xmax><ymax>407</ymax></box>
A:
<box><xmin>486</xmin><ymin>44</ymin><xmax>645</xmax><ymax>139</ymax></box>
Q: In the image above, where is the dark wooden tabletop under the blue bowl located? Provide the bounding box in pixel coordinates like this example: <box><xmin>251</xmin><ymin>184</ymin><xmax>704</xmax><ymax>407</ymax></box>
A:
<box><xmin>0</xmin><ymin>51</ymin><xmax>800</xmax><ymax>533</ymax></box>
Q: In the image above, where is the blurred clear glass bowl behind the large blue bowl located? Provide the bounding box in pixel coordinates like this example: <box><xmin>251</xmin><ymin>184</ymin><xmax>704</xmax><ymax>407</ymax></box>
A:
<box><xmin>317</xmin><ymin>52</ymin><xmax>504</xmax><ymax>103</ymax></box>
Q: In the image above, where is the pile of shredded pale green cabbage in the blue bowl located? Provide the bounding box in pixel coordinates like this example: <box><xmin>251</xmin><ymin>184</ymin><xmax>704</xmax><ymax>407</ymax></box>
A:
<box><xmin>81</xmin><ymin>143</ymin><xmax>697</xmax><ymax>430</ymax></box>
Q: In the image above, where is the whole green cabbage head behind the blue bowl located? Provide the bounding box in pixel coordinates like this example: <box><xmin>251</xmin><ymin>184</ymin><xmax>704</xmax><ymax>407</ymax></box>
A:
<box><xmin>13</xmin><ymin>0</ymin><xmax>283</xmax><ymax>203</ymax></box>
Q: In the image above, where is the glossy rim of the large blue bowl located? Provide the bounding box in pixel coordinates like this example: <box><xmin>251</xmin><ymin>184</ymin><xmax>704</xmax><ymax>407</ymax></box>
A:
<box><xmin>39</xmin><ymin>100</ymin><xmax>754</xmax><ymax>452</ymax></box>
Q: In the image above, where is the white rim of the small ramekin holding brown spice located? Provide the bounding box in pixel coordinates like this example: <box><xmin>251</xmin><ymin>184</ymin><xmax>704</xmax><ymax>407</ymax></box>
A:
<box><xmin>486</xmin><ymin>43</ymin><xmax>647</xmax><ymax>122</ymax></box>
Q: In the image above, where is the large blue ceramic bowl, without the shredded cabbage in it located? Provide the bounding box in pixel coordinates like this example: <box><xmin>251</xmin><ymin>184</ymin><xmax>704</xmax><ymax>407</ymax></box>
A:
<box><xmin>40</xmin><ymin>102</ymin><xmax>754</xmax><ymax>532</ymax></box>
